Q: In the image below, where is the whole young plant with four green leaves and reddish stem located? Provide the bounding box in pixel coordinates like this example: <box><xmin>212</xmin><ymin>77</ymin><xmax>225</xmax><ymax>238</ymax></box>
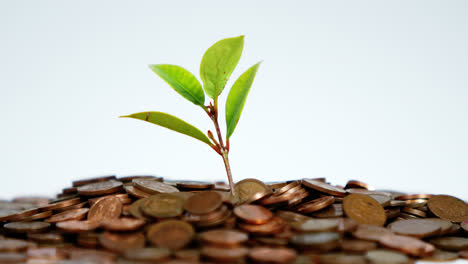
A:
<box><xmin>122</xmin><ymin>36</ymin><xmax>260</xmax><ymax>195</ymax></box>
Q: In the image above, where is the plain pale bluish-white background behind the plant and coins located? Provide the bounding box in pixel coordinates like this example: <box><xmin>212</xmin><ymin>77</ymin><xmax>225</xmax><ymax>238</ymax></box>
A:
<box><xmin>0</xmin><ymin>0</ymin><xmax>468</xmax><ymax>202</ymax></box>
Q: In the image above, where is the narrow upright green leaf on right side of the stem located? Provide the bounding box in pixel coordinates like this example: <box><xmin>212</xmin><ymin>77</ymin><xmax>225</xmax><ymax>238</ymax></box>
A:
<box><xmin>226</xmin><ymin>62</ymin><xmax>261</xmax><ymax>139</ymax></box>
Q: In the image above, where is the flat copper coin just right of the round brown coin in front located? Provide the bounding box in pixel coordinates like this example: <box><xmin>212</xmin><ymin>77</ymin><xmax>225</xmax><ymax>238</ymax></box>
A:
<box><xmin>200</xmin><ymin>229</ymin><xmax>249</xmax><ymax>247</ymax></box>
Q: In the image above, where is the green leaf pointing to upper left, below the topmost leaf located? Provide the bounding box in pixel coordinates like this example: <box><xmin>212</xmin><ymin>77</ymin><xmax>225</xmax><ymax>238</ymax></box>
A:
<box><xmin>149</xmin><ymin>64</ymin><xmax>205</xmax><ymax>107</ymax></box>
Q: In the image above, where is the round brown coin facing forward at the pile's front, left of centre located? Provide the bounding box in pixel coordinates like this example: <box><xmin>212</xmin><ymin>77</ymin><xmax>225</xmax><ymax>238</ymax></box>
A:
<box><xmin>147</xmin><ymin>220</ymin><xmax>195</xmax><ymax>250</ymax></box>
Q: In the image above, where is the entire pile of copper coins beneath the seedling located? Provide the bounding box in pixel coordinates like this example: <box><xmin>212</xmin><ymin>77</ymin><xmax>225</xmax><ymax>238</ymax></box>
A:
<box><xmin>0</xmin><ymin>176</ymin><xmax>468</xmax><ymax>264</ymax></box>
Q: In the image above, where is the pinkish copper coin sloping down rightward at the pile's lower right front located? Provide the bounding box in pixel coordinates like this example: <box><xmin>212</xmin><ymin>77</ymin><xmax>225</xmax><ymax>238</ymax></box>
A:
<box><xmin>379</xmin><ymin>235</ymin><xmax>435</xmax><ymax>257</ymax></box>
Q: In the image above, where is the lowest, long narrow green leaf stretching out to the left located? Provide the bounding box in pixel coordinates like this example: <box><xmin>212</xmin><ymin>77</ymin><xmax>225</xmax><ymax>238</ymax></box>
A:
<box><xmin>121</xmin><ymin>112</ymin><xmax>212</xmax><ymax>146</ymax></box>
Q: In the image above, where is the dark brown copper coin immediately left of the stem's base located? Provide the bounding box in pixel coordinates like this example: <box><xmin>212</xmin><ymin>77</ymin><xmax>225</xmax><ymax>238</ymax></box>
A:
<box><xmin>184</xmin><ymin>191</ymin><xmax>223</xmax><ymax>214</ymax></box>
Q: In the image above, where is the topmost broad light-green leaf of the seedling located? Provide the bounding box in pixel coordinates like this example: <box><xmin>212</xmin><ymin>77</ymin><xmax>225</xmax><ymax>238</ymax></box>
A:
<box><xmin>200</xmin><ymin>36</ymin><xmax>244</xmax><ymax>99</ymax></box>
